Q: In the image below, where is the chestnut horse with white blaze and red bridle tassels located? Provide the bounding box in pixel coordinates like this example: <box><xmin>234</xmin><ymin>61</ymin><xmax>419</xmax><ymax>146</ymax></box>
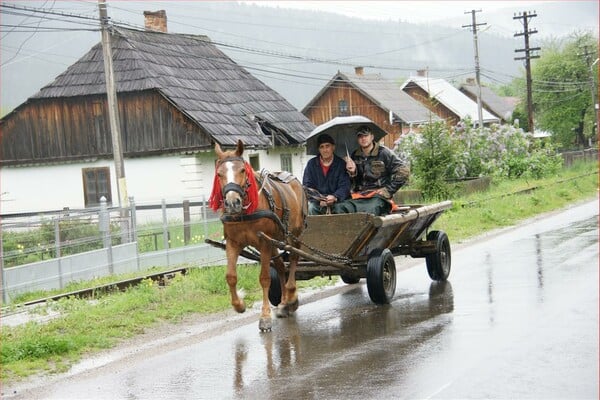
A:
<box><xmin>209</xmin><ymin>140</ymin><xmax>308</xmax><ymax>332</ymax></box>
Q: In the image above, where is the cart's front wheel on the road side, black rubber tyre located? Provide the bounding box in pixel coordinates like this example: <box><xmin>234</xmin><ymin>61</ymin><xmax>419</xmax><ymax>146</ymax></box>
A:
<box><xmin>367</xmin><ymin>249</ymin><xmax>396</xmax><ymax>304</ymax></box>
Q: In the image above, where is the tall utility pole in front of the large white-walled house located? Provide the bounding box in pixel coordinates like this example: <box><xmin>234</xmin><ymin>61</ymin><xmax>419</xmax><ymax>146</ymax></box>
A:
<box><xmin>98</xmin><ymin>0</ymin><xmax>128</xmax><ymax>208</ymax></box>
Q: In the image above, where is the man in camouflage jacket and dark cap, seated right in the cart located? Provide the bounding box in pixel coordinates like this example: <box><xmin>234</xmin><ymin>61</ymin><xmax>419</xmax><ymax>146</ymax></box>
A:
<box><xmin>338</xmin><ymin>126</ymin><xmax>410</xmax><ymax>215</ymax></box>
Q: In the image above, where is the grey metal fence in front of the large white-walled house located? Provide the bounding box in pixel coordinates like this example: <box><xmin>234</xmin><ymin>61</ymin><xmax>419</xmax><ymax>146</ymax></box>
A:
<box><xmin>0</xmin><ymin>198</ymin><xmax>231</xmax><ymax>304</ymax></box>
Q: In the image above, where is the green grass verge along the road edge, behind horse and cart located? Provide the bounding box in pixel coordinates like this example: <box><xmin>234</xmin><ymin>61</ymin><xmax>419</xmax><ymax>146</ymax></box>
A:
<box><xmin>0</xmin><ymin>159</ymin><xmax>598</xmax><ymax>384</ymax></box>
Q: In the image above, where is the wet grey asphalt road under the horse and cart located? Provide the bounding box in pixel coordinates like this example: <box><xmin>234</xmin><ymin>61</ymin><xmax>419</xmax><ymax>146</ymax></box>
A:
<box><xmin>5</xmin><ymin>201</ymin><xmax>599</xmax><ymax>399</ymax></box>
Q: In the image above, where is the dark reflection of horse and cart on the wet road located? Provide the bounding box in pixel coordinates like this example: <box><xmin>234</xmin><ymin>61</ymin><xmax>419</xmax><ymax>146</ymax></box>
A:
<box><xmin>233</xmin><ymin>281</ymin><xmax>454</xmax><ymax>398</ymax></box>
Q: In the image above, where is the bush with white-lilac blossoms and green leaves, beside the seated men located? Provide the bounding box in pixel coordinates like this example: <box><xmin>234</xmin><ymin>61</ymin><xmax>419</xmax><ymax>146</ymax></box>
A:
<box><xmin>396</xmin><ymin>119</ymin><xmax>562</xmax><ymax>198</ymax></box>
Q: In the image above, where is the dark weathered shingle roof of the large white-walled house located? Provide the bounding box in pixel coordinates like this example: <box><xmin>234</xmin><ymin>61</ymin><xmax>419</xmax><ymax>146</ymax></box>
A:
<box><xmin>32</xmin><ymin>28</ymin><xmax>314</xmax><ymax>146</ymax></box>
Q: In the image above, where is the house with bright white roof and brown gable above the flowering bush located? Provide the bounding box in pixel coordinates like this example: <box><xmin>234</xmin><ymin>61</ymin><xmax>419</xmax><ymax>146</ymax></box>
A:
<box><xmin>402</xmin><ymin>75</ymin><xmax>500</xmax><ymax>125</ymax></box>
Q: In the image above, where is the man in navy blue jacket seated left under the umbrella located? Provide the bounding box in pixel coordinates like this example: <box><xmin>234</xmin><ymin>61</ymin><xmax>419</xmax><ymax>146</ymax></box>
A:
<box><xmin>302</xmin><ymin>134</ymin><xmax>350</xmax><ymax>214</ymax></box>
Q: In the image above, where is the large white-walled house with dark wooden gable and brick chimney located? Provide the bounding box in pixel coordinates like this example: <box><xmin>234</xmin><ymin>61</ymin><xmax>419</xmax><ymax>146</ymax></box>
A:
<box><xmin>0</xmin><ymin>11</ymin><xmax>314</xmax><ymax>214</ymax></box>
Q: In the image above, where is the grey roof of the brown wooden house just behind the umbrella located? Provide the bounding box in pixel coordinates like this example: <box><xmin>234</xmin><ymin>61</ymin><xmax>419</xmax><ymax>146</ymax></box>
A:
<box><xmin>303</xmin><ymin>71</ymin><xmax>440</xmax><ymax>124</ymax></box>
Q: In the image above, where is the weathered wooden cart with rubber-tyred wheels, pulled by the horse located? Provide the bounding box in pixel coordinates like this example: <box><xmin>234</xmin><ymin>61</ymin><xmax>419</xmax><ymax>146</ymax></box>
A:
<box><xmin>207</xmin><ymin>201</ymin><xmax>452</xmax><ymax>306</ymax></box>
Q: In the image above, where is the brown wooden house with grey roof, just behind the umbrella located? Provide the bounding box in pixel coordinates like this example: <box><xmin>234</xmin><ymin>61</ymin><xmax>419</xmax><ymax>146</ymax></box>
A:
<box><xmin>302</xmin><ymin>67</ymin><xmax>439</xmax><ymax>148</ymax></box>
